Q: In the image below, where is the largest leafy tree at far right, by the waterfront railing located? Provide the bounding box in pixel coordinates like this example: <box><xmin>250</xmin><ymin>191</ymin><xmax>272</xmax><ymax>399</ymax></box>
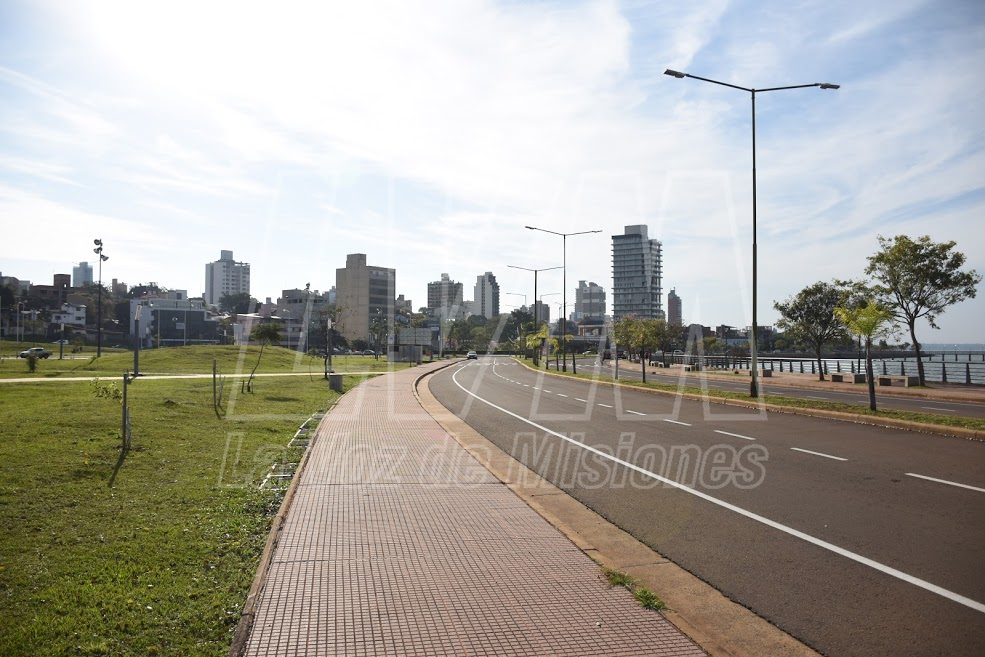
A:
<box><xmin>865</xmin><ymin>235</ymin><xmax>982</xmax><ymax>385</ymax></box>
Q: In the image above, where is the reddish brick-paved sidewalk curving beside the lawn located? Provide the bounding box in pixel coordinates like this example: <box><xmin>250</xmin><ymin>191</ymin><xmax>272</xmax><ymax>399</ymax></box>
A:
<box><xmin>245</xmin><ymin>365</ymin><xmax>705</xmax><ymax>657</ymax></box>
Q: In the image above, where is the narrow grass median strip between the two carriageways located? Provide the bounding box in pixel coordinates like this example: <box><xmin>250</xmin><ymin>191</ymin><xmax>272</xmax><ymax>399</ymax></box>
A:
<box><xmin>528</xmin><ymin>358</ymin><xmax>985</xmax><ymax>431</ymax></box>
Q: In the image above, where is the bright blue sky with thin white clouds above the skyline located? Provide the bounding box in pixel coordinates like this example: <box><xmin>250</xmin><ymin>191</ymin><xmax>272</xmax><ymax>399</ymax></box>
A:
<box><xmin>0</xmin><ymin>0</ymin><xmax>985</xmax><ymax>343</ymax></box>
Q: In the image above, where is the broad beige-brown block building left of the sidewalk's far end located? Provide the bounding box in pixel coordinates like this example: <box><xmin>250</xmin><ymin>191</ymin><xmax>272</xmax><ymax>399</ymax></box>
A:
<box><xmin>335</xmin><ymin>253</ymin><xmax>397</xmax><ymax>340</ymax></box>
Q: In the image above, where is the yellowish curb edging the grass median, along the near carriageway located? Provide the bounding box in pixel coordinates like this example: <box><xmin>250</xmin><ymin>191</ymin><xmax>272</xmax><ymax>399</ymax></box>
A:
<box><xmin>513</xmin><ymin>358</ymin><xmax>985</xmax><ymax>441</ymax></box>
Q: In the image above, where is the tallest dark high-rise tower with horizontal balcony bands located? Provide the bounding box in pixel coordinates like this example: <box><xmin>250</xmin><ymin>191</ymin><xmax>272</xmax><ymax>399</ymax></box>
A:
<box><xmin>612</xmin><ymin>225</ymin><xmax>664</xmax><ymax>320</ymax></box>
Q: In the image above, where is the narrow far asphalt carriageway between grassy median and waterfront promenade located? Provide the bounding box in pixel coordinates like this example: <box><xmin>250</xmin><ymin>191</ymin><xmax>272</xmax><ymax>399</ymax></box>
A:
<box><xmin>551</xmin><ymin>358</ymin><xmax>985</xmax><ymax>418</ymax></box>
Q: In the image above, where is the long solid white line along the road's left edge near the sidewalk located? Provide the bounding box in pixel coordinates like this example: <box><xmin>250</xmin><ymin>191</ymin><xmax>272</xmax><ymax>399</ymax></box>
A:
<box><xmin>451</xmin><ymin>369</ymin><xmax>985</xmax><ymax>614</ymax></box>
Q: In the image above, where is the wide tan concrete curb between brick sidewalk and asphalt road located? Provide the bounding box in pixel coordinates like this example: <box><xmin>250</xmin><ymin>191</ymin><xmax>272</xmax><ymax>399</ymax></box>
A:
<box><xmin>414</xmin><ymin>361</ymin><xmax>820</xmax><ymax>657</ymax></box>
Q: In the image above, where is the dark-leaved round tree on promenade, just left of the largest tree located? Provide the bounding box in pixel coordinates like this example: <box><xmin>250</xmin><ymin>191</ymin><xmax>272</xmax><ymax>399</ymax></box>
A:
<box><xmin>773</xmin><ymin>281</ymin><xmax>846</xmax><ymax>381</ymax></box>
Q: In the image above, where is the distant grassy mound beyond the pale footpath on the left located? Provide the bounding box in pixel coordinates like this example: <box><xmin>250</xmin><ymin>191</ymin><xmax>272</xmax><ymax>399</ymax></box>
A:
<box><xmin>0</xmin><ymin>345</ymin><xmax>408</xmax><ymax>379</ymax></box>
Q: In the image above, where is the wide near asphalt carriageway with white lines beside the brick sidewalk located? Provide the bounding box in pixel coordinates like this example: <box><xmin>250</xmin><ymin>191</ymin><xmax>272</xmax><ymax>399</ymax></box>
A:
<box><xmin>430</xmin><ymin>358</ymin><xmax>985</xmax><ymax>657</ymax></box>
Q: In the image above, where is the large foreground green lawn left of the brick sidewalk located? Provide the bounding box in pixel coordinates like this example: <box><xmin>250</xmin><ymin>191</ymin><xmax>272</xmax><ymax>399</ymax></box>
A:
<box><xmin>0</xmin><ymin>368</ymin><xmax>357</xmax><ymax>656</ymax></box>
